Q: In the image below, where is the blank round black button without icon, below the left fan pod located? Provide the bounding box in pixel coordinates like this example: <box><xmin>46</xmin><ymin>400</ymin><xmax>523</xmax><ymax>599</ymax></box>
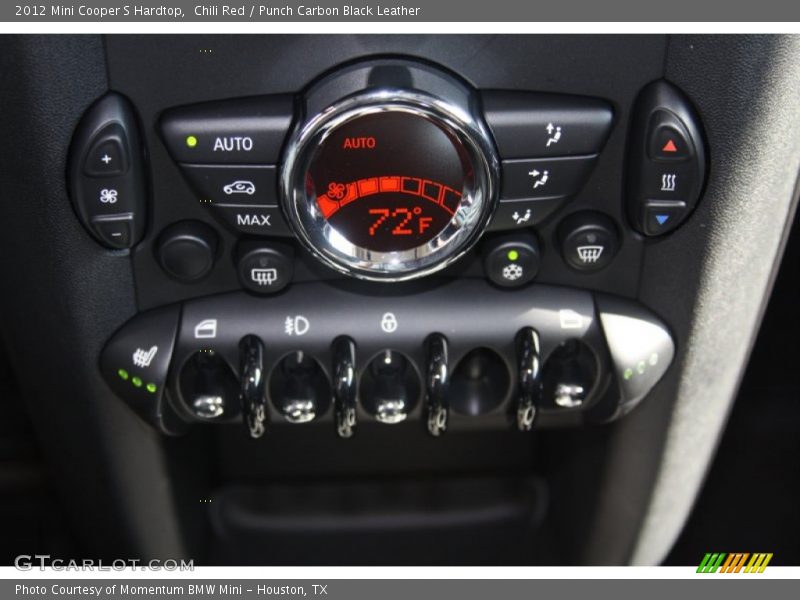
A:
<box><xmin>156</xmin><ymin>221</ymin><xmax>217</xmax><ymax>283</ymax></box>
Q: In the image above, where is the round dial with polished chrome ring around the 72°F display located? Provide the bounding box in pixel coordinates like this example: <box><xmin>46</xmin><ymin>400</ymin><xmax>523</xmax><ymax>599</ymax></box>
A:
<box><xmin>281</xmin><ymin>89</ymin><xmax>498</xmax><ymax>281</ymax></box>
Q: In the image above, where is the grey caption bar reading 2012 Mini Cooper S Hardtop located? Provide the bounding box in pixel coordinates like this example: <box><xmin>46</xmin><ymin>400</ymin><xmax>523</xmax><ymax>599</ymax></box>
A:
<box><xmin>0</xmin><ymin>0</ymin><xmax>800</xmax><ymax>23</ymax></box>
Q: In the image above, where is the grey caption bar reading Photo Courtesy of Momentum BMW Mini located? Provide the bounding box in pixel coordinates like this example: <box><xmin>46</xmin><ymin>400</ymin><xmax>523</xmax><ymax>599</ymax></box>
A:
<box><xmin>0</xmin><ymin>580</ymin><xmax>797</xmax><ymax>600</ymax></box>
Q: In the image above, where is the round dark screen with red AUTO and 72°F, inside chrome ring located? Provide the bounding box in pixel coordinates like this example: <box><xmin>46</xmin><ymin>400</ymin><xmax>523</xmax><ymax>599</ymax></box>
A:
<box><xmin>307</xmin><ymin>111</ymin><xmax>468</xmax><ymax>252</ymax></box>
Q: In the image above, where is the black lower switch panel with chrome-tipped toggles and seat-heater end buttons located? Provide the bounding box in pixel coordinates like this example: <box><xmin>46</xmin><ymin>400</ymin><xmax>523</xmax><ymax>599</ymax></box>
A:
<box><xmin>100</xmin><ymin>280</ymin><xmax>674</xmax><ymax>438</ymax></box>
